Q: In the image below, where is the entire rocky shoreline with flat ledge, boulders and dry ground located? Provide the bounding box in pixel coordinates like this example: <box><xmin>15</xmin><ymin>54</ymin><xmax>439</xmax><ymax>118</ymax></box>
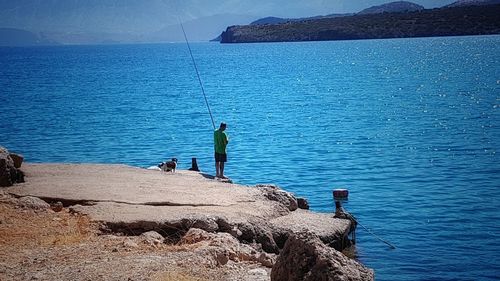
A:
<box><xmin>0</xmin><ymin>145</ymin><xmax>373</xmax><ymax>280</ymax></box>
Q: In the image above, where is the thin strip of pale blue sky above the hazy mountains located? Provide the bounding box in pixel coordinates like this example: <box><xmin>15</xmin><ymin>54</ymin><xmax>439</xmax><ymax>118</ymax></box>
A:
<box><xmin>0</xmin><ymin>0</ymin><xmax>455</xmax><ymax>18</ymax></box>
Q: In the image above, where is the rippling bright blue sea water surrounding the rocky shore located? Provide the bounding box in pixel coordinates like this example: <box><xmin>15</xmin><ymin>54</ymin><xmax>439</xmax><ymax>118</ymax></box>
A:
<box><xmin>0</xmin><ymin>36</ymin><xmax>500</xmax><ymax>280</ymax></box>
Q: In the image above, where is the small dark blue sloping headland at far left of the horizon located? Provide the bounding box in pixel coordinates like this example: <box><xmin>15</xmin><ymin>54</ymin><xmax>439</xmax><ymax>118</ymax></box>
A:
<box><xmin>0</xmin><ymin>28</ymin><xmax>58</xmax><ymax>46</ymax></box>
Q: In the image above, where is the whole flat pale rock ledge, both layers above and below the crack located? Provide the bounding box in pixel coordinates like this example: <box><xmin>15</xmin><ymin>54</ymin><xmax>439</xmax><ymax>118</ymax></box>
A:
<box><xmin>5</xmin><ymin>164</ymin><xmax>349</xmax><ymax>242</ymax></box>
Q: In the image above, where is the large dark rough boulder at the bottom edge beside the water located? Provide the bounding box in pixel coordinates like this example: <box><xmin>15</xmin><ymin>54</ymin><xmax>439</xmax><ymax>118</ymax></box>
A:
<box><xmin>271</xmin><ymin>231</ymin><xmax>374</xmax><ymax>281</ymax></box>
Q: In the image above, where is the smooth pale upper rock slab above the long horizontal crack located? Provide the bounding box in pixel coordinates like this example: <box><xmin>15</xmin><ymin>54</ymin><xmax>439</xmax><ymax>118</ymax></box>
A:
<box><xmin>7</xmin><ymin>164</ymin><xmax>257</xmax><ymax>206</ymax></box>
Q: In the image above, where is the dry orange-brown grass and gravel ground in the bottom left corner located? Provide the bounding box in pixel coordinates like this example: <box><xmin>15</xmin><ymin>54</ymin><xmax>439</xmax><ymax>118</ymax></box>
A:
<box><xmin>0</xmin><ymin>190</ymin><xmax>269</xmax><ymax>281</ymax></box>
